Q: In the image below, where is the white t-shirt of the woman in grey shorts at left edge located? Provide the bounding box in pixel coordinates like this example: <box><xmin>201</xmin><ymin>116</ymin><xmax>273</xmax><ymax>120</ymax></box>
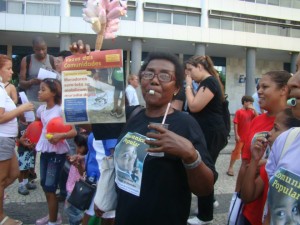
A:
<box><xmin>0</xmin><ymin>83</ymin><xmax>18</xmax><ymax>137</ymax></box>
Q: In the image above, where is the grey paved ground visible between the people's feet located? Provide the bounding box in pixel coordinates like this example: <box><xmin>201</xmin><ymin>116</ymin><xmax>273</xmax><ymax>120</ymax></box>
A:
<box><xmin>4</xmin><ymin>138</ymin><xmax>240</xmax><ymax>225</ymax></box>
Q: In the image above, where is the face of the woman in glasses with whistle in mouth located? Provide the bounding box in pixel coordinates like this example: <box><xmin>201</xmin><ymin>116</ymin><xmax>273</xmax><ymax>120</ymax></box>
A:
<box><xmin>141</xmin><ymin>59</ymin><xmax>178</xmax><ymax>107</ymax></box>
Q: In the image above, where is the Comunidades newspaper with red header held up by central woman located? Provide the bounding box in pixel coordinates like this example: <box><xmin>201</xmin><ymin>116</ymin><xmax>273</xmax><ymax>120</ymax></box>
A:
<box><xmin>62</xmin><ymin>49</ymin><xmax>125</xmax><ymax>124</ymax></box>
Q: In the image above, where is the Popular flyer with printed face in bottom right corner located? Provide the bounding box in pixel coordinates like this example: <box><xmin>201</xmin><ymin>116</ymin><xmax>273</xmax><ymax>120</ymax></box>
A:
<box><xmin>268</xmin><ymin>168</ymin><xmax>300</xmax><ymax>225</ymax></box>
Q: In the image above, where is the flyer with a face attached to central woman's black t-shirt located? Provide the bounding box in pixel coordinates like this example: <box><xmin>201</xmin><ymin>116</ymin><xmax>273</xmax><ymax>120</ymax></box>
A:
<box><xmin>114</xmin><ymin>132</ymin><xmax>149</xmax><ymax>196</ymax></box>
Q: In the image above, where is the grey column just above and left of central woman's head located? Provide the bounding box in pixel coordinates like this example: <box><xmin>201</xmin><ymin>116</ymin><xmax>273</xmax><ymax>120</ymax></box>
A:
<box><xmin>131</xmin><ymin>38</ymin><xmax>142</xmax><ymax>74</ymax></box>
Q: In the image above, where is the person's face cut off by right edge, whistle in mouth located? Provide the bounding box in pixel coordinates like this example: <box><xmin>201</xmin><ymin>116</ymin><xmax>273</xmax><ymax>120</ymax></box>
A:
<box><xmin>288</xmin><ymin>71</ymin><xmax>300</xmax><ymax>119</ymax></box>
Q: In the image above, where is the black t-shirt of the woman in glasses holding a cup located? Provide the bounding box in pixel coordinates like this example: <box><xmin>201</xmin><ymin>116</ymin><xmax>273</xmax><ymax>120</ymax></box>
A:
<box><xmin>115</xmin><ymin>110</ymin><xmax>217</xmax><ymax>225</ymax></box>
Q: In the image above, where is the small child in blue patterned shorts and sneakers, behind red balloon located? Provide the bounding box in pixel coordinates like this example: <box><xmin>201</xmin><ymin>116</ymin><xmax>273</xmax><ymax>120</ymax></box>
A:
<box><xmin>18</xmin><ymin>115</ymin><xmax>36</xmax><ymax>195</ymax></box>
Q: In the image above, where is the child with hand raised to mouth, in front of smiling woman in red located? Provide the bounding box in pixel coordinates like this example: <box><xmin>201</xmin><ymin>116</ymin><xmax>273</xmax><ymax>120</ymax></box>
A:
<box><xmin>241</xmin><ymin>108</ymin><xmax>300</xmax><ymax>225</ymax></box>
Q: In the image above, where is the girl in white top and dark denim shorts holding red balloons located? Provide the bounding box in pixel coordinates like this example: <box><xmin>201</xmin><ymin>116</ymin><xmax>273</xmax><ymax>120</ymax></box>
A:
<box><xmin>36</xmin><ymin>78</ymin><xmax>76</xmax><ymax>225</ymax></box>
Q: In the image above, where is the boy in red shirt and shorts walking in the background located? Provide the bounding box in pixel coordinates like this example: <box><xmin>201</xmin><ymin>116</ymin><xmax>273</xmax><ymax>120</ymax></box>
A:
<box><xmin>227</xmin><ymin>95</ymin><xmax>257</xmax><ymax>176</ymax></box>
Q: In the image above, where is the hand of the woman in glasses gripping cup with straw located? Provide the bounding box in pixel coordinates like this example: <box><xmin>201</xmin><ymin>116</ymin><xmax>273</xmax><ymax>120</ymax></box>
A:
<box><xmin>145</xmin><ymin>124</ymin><xmax>197</xmax><ymax>163</ymax></box>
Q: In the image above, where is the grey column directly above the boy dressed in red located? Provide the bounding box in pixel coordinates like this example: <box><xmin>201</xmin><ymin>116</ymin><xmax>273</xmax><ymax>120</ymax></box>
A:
<box><xmin>245</xmin><ymin>48</ymin><xmax>256</xmax><ymax>96</ymax></box>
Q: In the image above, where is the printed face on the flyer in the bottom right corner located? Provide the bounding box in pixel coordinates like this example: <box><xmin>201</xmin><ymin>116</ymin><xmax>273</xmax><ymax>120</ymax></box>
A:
<box><xmin>271</xmin><ymin>194</ymin><xmax>300</xmax><ymax>225</ymax></box>
